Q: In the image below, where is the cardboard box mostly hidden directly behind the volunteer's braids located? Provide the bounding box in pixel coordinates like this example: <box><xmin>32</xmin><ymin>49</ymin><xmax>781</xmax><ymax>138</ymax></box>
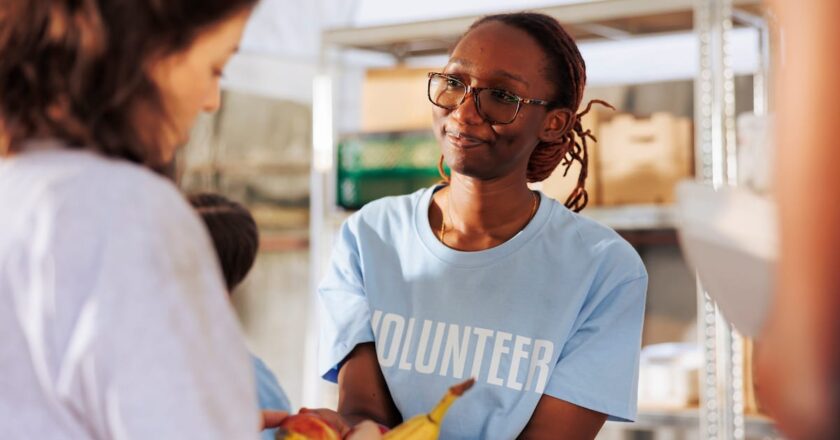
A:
<box><xmin>531</xmin><ymin>109</ymin><xmax>602</xmax><ymax>206</ymax></box>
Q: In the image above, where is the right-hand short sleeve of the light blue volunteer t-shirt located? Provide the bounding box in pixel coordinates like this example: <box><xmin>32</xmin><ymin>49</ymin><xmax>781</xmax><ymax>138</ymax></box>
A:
<box><xmin>544</xmin><ymin>275</ymin><xmax>647</xmax><ymax>421</ymax></box>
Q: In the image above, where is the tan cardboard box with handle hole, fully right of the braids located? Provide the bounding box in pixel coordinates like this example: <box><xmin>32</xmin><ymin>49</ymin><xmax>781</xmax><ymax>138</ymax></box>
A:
<box><xmin>597</xmin><ymin>113</ymin><xmax>693</xmax><ymax>205</ymax></box>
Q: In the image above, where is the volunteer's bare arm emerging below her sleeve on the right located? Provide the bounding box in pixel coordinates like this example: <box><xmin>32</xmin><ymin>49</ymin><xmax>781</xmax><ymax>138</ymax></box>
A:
<box><xmin>519</xmin><ymin>394</ymin><xmax>607</xmax><ymax>440</ymax></box>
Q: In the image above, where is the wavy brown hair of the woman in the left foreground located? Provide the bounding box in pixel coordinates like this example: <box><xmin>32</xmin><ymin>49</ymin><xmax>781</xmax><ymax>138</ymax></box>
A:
<box><xmin>0</xmin><ymin>0</ymin><xmax>257</xmax><ymax>166</ymax></box>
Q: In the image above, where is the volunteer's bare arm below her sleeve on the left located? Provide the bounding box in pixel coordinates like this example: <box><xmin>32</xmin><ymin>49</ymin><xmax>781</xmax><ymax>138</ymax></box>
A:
<box><xmin>338</xmin><ymin>342</ymin><xmax>402</xmax><ymax>427</ymax></box>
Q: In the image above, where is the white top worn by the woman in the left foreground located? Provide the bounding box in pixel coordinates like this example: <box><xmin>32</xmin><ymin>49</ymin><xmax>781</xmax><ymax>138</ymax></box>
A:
<box><xmin>0</xmin><ymin>142</ymin><xmax>259</xmax><ymax>440</ymax></box>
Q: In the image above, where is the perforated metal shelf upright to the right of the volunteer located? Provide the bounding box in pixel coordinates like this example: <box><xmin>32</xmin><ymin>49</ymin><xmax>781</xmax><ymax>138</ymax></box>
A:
<box><xmin>694</xmin><ymin>0</ymin><xmax>744</xmax><ymax>440</ymax></box>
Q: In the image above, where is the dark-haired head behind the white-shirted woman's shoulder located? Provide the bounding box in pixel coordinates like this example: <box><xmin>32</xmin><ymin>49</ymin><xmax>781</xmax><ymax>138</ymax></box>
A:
<box><xmin>188</xmin><ymin>193</ymin><xmax>259</xmax><ymax>292</ymax></box>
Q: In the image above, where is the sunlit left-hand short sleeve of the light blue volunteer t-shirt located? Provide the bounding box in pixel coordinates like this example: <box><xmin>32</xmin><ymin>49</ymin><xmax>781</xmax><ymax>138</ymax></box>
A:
<box><xmin>318</xmin><ymin>216</ymin><xmax>374</xmax><ymax>382</ymax></box>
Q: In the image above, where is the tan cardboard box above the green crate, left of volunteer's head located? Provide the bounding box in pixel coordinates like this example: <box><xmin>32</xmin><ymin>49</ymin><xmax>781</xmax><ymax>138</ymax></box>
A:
<box><xmin>361</xmin><ymin>67</ymin><xmax>435</xmax><ymax>132</ymax></box>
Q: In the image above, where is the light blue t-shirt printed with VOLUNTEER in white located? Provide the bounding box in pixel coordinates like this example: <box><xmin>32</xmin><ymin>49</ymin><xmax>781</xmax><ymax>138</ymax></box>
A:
<box><xmin>319</xmin><ymin>188</ymin><xmax>647</xmax><ymax>439</ymax></box>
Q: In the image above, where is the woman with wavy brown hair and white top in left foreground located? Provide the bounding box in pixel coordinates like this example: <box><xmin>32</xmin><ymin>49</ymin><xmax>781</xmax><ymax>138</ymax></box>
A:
<box><xmin>0</xmin><ymin>0</ymin><xmax>260</xmax><ymax>439</ymax></box>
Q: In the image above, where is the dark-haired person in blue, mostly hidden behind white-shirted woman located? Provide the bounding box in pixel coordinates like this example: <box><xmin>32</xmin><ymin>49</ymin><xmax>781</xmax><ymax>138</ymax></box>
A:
<box><xmin>188</xmin><ymin>193</ymin><xmax>292</xmax><ymax>440</ymax></box>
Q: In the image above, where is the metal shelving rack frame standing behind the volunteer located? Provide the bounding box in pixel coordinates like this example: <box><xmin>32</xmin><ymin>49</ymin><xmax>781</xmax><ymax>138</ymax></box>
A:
<box><xmin>303</xmin><ymin>0</ymin><xmax>778</xmax><ymax>440</ymax></box>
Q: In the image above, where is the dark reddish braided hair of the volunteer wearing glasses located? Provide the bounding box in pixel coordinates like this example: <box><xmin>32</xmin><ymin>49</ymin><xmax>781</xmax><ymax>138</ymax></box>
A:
<box><xmin>438</xmin><ymin>12</ymin><xmax>613</xmax><ymax>212</ymax></box>
